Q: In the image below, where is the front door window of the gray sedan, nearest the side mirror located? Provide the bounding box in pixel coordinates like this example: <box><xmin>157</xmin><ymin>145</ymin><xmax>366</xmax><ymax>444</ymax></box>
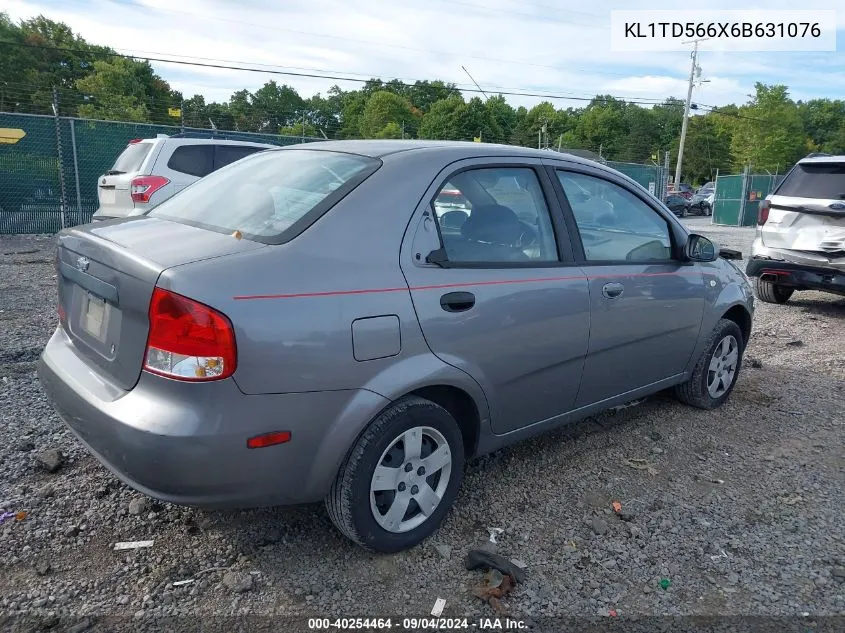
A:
<box><xmin>557</xmin><ymin>171</ymin><xmax>672</xmax><ymax>262</ymax></box>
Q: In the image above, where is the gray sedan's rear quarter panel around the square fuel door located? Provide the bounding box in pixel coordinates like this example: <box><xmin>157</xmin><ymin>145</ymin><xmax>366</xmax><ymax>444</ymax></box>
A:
<box><xmin>159</xmin><ymin>152</ymin><xmax>483</xmax><ymax>401</ymax></box>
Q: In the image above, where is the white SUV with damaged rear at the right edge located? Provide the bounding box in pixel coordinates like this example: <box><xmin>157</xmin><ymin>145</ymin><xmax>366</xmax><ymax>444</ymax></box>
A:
<box><xmin>746</xmin><ymin>155</ymin><xmax>845</xmax><ymax>303</ymax></box>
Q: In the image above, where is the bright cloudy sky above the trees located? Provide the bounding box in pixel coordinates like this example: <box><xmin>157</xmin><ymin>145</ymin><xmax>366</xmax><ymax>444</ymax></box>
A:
<box><xmin>3</xmin><ymin>0</ymin><xmax>845</xmax><ymax>107</ymax></box>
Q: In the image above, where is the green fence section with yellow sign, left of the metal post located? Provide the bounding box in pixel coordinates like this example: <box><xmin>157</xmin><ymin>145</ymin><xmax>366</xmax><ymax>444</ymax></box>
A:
<box><xmin>0</xmin><ymin>113</ymin><xmax>61</xmax><ymax>234</ymax></box>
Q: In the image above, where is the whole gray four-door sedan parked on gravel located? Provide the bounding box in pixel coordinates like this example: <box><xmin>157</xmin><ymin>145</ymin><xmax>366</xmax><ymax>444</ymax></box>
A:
<box><xmin>39</xmin><ymin>141</ymin><xmax>753</xmax><ymax>552</ymax></box>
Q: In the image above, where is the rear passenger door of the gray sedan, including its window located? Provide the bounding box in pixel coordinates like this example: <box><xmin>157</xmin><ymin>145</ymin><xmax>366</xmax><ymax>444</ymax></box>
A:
<box><xmin>400</xmin><ymin>158</ymin><xmax>589</xmax><ymax>434</ymax></box>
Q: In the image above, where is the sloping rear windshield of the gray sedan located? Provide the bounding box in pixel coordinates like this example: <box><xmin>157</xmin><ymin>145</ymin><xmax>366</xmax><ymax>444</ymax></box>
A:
<box><xmin>148</xmin><ymin>149</ymin><xmax>381</xmax><ymax>244</ymax></box>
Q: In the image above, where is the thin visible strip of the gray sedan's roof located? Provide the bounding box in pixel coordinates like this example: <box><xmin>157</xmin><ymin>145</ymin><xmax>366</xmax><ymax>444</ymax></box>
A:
<box><xmin>270</xmin><ymin>139</ymin><xmax>601</xmax><ymax>166</ymax></box>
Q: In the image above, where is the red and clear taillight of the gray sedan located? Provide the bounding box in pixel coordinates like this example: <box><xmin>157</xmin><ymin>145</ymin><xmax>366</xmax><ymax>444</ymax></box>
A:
<box><xmin>144</xmin><ymin>288</ymin><xmax>237</xmax><ymax>381</ymax></box>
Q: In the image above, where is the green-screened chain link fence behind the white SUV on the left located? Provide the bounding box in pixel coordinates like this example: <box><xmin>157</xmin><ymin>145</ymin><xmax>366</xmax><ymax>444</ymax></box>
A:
<box><xmin>0</xmin><ymin>112</ymin><xmax>320</xmax><ymax>234</ymax></box>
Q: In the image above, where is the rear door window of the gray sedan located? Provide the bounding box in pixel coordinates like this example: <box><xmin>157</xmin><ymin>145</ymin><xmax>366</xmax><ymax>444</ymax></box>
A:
<box><xmin>432</xmin><ymin>167</ymin><xmax>558</xmax><ymax>264</ymax></box>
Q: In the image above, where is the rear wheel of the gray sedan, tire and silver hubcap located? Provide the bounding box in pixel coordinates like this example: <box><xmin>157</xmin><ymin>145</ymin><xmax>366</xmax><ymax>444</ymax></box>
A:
<box><xmin>326</xmin><ymin>396</ymin><xmax>464</xmax><ymax>553</ymax></box>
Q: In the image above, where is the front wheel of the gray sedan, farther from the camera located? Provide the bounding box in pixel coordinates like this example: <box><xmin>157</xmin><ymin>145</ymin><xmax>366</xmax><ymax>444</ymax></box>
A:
<box><xmin>675</xmin><ymin>319</ymin><xmax>745</xmax><ymax>409</ymax></box>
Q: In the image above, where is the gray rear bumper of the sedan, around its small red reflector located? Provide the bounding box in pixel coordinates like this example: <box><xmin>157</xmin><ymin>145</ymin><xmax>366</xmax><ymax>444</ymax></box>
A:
<box><xmin>38</xmin><ymin>328</ymin><xmax>385</xmax><ymax>508</ymax></box>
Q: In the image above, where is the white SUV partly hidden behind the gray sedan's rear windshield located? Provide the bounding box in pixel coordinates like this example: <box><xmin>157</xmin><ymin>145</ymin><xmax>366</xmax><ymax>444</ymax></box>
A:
<box><xmin>93</xmin><ymin>134</ymin><xmax>276</xmax><ymax>220</ymax></box>
